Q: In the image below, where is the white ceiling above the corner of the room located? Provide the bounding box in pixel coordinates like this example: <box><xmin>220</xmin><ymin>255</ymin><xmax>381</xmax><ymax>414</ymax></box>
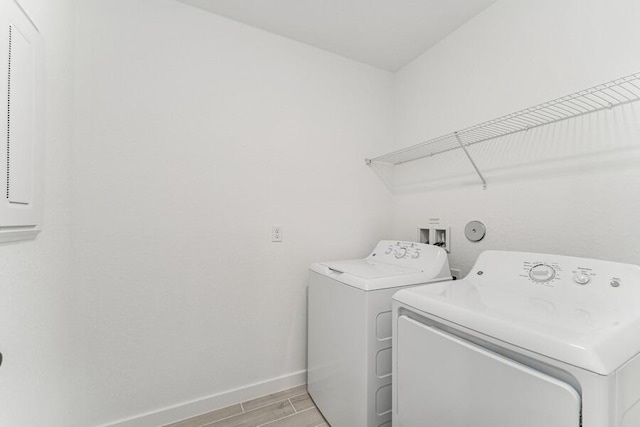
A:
<box><xmin>178</xmin><ymin>0</ymin><xmax>496</xmax><ymax>71</ymax></box>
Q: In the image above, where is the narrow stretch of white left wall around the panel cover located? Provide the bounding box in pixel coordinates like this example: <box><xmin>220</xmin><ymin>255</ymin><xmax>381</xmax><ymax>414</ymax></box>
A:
<box><xmin>0</xmin><ymin>0</ymin><xmax>77</xmax><ymax>426</ymax></box>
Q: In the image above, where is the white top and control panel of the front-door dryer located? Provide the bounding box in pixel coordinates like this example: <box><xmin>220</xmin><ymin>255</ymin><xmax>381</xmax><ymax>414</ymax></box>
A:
<box><xmin>394</xmin><ymin>251</ymin><xmax>640</xmax><ymax>375</ymax></box>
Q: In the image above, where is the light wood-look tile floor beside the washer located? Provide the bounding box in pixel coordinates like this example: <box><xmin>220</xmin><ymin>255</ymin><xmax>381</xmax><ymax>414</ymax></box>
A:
<box><xmin>165</xmin><ymin>384</ymin><xmax>329</xmax><ymax>427</ymax></box>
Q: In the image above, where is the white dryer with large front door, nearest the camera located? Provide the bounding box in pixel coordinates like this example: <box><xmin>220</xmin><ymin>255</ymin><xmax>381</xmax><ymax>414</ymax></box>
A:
<box><xmin>393</xmin><ymin>251</ymin><xmax>640</xmax><ymax>427</ymax></box>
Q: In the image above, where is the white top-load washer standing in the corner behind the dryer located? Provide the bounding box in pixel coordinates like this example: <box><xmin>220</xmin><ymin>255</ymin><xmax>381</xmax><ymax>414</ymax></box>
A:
<box><xmin>307</xmin><ymin>241</ymin><xmax>451</xmax><ymax>427</ymax></box>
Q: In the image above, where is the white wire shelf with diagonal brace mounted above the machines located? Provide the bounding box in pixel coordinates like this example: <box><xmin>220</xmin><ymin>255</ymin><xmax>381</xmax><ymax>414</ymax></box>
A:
<box><xmin>365</xmin><ymin>73</ymin><xmax>640</xmax><ymax>188</ymax></box>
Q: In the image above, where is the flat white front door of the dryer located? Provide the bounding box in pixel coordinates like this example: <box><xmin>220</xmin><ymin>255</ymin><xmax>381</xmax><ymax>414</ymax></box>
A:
<box><xmin>394</xmin><ymin>316</ymin><xmax>580</xmax><ymax>427</ymax></box>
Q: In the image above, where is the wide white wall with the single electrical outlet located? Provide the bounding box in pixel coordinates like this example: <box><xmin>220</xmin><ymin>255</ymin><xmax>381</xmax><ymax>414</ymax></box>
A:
<box><xmin>74</xmin><ymin>0</ymin><xmax>392</xmax><ymax>425</ymax></box>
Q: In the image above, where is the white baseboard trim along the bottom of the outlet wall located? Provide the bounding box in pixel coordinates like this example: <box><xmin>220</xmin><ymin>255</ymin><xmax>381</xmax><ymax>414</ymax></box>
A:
<box><xmin>100</xmin><ymin>371</ymin><xmax>307</xmax><ymax>427</ymax></box>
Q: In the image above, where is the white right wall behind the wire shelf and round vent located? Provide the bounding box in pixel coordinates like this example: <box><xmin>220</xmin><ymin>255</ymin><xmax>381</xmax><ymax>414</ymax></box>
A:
<box><xmin>389</xmin><ymin>0</ymin><xmax>640</xmax><ymax>274</ymax></box>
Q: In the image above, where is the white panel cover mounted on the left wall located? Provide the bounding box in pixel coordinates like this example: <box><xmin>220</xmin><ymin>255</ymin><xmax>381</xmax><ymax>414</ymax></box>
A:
<box><xmin>0</xmin><ymin>0</ymin><xmax>44</xmax><ymax>242</ymax></box>
